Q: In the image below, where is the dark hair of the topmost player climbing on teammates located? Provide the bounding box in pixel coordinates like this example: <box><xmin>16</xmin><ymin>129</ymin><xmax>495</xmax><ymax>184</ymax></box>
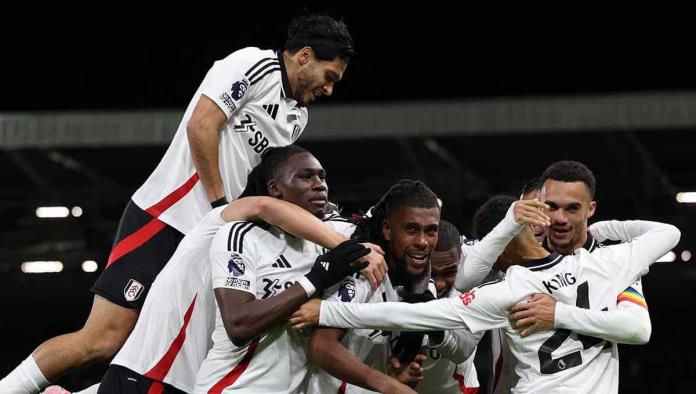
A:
<box><xmin>285</xmin><ymin>14</ymin><xmax>355</xmax><ymax>62</ymax></box>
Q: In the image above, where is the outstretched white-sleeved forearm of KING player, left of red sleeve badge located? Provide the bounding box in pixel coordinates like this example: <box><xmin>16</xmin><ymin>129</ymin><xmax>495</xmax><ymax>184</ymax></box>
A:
<box><xmin>319</xmin><ymin>298</ymin><xmax>466</xmax><ymax>331</ymax></box>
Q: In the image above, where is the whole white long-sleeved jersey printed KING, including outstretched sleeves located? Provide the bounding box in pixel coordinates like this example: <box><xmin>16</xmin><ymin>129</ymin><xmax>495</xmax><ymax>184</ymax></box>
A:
<box><xmin>319</xmin><ymin>221</ymin><xmax>679</xmax><ymax>393</ymax></box>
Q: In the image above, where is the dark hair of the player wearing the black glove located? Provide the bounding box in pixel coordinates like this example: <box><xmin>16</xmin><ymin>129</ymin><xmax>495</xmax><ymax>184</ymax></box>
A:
<box><xmin>239</xmin><ymin>145</ymin><xmax>311</xmax><ymax>198</ymax></box>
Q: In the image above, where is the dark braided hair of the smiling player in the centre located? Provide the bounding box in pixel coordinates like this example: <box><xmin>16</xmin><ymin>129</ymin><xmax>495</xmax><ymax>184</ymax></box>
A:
<box><xmin>352</xmin><ymin>179</ymin><xmax>440</xmax><ymax>250</ymax></box>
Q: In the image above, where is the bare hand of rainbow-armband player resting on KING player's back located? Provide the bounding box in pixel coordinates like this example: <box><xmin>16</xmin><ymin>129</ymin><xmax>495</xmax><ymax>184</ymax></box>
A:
<box><xmin>510</xmin><ymin>294</ymin><xmax>556</xmax><ymax>338</ymax></box>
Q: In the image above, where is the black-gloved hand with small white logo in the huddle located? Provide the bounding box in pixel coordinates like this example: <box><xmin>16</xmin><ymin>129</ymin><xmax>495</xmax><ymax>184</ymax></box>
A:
<box><xmin>305</xmin><ymin>239</ymin><xmax>370</xmax><ymax>292</ymax></box>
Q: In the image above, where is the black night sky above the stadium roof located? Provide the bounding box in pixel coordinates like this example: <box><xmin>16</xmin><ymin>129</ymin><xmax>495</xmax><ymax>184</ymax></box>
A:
<box><xmin>5</xmin><ymin>4</ymin><xmax>696</xmax><ymax>111</ymax></box>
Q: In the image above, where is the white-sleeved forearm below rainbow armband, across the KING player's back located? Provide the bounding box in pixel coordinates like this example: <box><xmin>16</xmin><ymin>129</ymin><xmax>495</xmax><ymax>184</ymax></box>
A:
<box><xmin>554</xmin><ymin>302</ymin><xmax>652</xmax><ymax>345</ymax></box>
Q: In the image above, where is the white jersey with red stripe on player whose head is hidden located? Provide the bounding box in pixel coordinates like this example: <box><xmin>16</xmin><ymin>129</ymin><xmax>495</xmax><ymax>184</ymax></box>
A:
<box><xmin>112</xmin><ymin>207</ymin><xmax>225</xmax><ymax>392</ymax></box>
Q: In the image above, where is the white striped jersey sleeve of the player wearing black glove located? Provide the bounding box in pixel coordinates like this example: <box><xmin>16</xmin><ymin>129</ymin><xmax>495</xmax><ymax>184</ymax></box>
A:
<box><xmin>209</xmin><ymin>222</ymin><xmax>258</xmax><ymax>296</ymax></box>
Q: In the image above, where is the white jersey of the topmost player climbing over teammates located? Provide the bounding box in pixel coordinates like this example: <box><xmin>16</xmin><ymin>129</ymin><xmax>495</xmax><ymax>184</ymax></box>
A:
<box><xmin>132</xmin><ymin>47</ymin><xmax>307</xmax><ymax>234</ymax></box>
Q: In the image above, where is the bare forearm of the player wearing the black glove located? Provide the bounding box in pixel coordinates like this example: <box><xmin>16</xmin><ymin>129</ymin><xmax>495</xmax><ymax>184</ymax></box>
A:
<box><xmin>218</xmin><ymin>283</ymin><xmax>308</xmax><ymax>345</ymax></box>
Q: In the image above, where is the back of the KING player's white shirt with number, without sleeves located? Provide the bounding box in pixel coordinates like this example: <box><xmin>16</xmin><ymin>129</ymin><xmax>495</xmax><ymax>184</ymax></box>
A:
<box><xmin>498</xmin><ymin>249</ymin><xmax>630</xmax><ymax>393</ymax></box>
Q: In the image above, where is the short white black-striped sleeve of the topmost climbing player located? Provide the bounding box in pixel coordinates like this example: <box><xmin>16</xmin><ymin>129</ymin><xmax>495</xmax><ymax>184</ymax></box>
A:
<box><xmin>201</xmin><ymin>48</ymin><xmax>268</xmax><ymax>119</ymax></box>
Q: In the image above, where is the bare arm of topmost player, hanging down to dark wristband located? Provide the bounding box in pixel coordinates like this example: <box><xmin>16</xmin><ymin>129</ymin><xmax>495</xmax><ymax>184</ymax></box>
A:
<box><xmin>187</xmin><ymin>119</ymin><xmax>223</xmax><ymax>202</ymax></box>
